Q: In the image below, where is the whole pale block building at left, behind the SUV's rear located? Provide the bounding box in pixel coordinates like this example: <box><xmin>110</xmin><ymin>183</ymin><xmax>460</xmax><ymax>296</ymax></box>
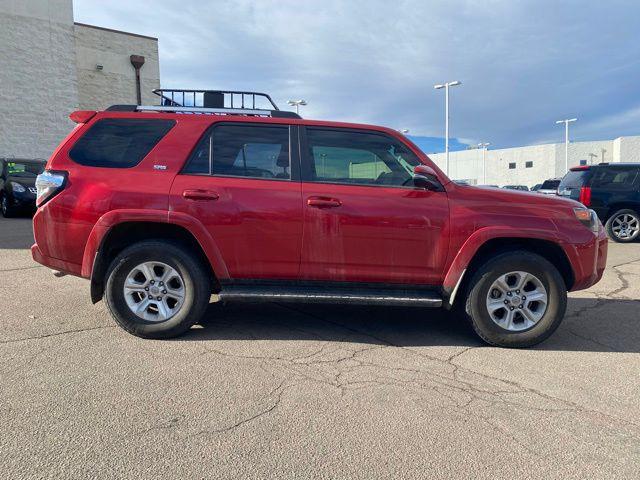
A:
<box><xmin>0</xmin><ymin>0</ymin><xmax>160</xmax><ymax>158</ymax></box>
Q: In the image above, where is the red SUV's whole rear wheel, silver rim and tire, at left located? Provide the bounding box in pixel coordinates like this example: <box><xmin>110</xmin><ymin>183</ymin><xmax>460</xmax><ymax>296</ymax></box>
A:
<box><xmin>105</xmin><ymin>241</ymin><xmax>211</xmax><ymax>338</ymax></box>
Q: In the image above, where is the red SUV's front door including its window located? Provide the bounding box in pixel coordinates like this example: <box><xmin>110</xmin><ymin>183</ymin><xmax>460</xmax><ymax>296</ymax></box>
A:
<box><xmin>301</xmin><ymin>127</ymin><xmax>449</xmax><ymax>285</ymax></box>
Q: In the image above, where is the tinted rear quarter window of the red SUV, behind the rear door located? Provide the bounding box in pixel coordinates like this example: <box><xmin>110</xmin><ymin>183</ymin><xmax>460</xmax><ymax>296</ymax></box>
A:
<box><xmin>69</xmin><ymin>118</ymin><xmax>175</xmax><ymax>168</ymax></box>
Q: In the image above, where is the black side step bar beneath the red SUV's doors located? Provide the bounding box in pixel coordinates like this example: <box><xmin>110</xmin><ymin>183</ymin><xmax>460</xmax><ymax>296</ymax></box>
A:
<box><xmin>218</xmin><ymin>284</ymin><xmax>442</xmax><ymax>308</ymax></box>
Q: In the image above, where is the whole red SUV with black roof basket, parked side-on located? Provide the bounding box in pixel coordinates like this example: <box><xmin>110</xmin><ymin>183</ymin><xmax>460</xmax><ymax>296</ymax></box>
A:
<box><xmin>32</xmin><ymin>90</ymin><xmax>607</xmax><ymax>347</ymax></box>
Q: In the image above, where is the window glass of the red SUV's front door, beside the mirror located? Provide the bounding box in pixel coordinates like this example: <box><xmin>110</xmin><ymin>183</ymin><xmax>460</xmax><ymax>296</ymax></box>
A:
<box><xmin>307</xmin><ymin>128</ymin><xmax>420</xmax><ymax>186</ymax></box>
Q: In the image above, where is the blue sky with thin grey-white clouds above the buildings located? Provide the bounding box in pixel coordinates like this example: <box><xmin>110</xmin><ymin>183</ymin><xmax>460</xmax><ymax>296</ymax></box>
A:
<box><xmin>74</xmin><ymin>0</ymin><xmax>640</xmax><ymax>153</ymax></box>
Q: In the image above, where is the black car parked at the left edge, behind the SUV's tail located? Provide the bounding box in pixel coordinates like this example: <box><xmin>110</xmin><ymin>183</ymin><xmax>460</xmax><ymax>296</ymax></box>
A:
<box><xmin>0</xmin><ymin>158</ymin><xmax>45</xmax><ymax>217</ymax></box>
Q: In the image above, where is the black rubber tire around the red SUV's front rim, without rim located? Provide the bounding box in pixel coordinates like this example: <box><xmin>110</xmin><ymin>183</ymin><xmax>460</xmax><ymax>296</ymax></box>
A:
<box><xmin>464</xmin><ymin>250</ymin><xmax>567</xmax><ymax>348</ymax></box>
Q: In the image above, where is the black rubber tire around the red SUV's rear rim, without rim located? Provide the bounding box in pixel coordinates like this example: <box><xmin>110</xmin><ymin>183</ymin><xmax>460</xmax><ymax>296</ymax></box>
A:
<box><xmin>105</xmin><ymin>240</ymin><xmax>211</xmax><ymax>338</ymax></box>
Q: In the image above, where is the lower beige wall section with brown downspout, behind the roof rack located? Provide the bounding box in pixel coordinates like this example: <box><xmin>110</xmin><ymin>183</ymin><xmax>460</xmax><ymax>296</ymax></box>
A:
<box><xmin>74</xmin><ymin>23</ymin><xmax>160</xmax><ymax>110</ymax></box>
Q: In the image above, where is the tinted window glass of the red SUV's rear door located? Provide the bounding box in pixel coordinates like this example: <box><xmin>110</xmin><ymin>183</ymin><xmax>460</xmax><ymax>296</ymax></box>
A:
<box><xmin>184</xmin><ymin>125</ymin><xmax>291</xmax><ymax>180</ymax></box>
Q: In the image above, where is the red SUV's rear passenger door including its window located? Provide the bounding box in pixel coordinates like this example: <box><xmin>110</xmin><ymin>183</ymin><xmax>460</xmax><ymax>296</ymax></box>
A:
<box><xmin>170</xmin><ymin>122</ymin><xmax>302</xmax><ymax>279</ymax></box>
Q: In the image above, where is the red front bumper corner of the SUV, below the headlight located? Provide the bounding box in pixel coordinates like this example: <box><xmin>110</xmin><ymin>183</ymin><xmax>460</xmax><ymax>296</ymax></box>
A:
<box><xmin>567</xmin><ymin>227</ymin><xmax>609</xmax><ymax>291</ymax></box>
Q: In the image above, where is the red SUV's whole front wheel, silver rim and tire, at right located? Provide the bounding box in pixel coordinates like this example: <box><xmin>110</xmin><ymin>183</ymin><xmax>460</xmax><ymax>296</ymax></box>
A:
<box><xmin>465</xmin><ymin>251</ymin><xmax>567</xmax><ymax>347</ymax></box>
